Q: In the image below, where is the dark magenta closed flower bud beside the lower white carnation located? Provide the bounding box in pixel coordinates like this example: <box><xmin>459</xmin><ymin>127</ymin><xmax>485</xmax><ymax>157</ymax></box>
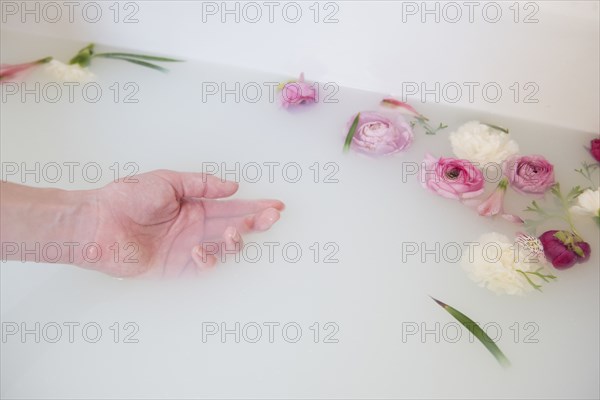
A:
<box><xmin>540</xmin><ymin>231</ymin><xmax>591</xmax><ymax>269</ymax></box>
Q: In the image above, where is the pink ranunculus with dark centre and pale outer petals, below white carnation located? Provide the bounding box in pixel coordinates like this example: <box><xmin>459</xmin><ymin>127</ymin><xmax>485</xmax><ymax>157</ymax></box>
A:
<box><xmin>421</xmin><ymin>154</ymin><xmax>485</xmax><ymax>199</ymax></box>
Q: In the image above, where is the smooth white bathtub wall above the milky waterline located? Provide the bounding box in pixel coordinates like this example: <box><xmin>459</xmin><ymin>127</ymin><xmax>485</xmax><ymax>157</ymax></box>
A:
<box><xmin>2</xmin><ymin>1</ymin><xmax>600</xmax><ymax>132</ymax></box>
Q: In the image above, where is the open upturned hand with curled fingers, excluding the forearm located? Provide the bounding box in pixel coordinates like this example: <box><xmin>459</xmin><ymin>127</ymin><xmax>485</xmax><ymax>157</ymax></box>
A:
<box><xmin>85</xmin><ymin>170</ymin><xmax>284</xmax><ymax>277</ymax></box>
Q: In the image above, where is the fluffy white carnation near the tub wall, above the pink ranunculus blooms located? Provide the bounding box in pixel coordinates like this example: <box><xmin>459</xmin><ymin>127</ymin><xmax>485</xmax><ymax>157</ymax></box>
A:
<box><xmin>450</xmin><ymin>121</ymin><xmax>519</xmax><ymax>166</ymax></box>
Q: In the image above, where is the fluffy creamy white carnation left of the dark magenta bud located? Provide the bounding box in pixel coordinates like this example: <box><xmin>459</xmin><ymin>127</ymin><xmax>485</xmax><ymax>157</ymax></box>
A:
<box><xmin>461</xmin><ymin>232</ymin><xmax>544</xmax><ymax>295</ymax></box>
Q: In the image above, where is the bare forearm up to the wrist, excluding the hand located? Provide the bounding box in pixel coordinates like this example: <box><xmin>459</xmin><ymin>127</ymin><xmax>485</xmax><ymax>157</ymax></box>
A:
<box><xmin>0</xmin><ymin>182</ymin><xmax>97</xmax><ymax>265</ymax></box>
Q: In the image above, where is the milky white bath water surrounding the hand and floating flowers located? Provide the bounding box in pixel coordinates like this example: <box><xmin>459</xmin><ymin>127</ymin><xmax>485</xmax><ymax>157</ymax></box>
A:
<box><xmin>0</xmin><ymin>32</ymin><xmax>600</xmax><ymax>398</ymax></box>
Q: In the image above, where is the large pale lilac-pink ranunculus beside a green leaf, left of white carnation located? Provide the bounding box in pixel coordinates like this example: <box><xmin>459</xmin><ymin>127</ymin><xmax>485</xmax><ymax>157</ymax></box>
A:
<box><xmin>347</xmin><ymin>111</ymin><xmax>413</xmax><ymax>156</ymax></box>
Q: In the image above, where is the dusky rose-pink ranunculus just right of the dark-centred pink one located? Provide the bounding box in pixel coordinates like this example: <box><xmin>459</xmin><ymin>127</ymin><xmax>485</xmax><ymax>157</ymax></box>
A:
<box><xmin>503</xmin><ymin>155</ymin><xmax>555</xmax><ymax>194</ymax></box>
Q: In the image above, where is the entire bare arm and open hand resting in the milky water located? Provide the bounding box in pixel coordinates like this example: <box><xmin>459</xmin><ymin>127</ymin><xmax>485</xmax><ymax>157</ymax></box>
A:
<box><xmin>0</xmin><ymin>170</ymin><xmax>284</xmax><ymax>277</ymax></box>
